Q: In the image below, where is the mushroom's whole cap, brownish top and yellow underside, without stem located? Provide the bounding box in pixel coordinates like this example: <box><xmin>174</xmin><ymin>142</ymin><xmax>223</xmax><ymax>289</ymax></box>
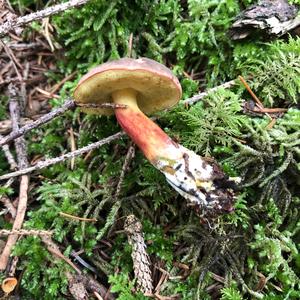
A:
<box><xmin>74</xmin><ymin>58</ymin><xmax>181</xmax><ymax>115</ymax></box>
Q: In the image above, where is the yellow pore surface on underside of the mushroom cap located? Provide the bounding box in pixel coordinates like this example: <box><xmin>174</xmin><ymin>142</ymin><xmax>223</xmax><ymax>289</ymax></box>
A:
<box><xmin>74</xmin><ymin>69</ymin><xmax>181</xmax><ymax>115</ymax></box>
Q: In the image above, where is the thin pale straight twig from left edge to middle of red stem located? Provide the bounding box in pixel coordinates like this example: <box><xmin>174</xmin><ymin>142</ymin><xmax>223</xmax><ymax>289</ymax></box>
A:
<box><xmin>0</xmin><ymin>131</ymin><xmax>125</xmax><ymax>180</ymax></box>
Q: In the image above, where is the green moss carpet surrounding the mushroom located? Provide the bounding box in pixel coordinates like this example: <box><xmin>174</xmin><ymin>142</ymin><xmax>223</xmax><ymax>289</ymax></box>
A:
<box><xmin>0</xmin><ymin>0</ymin><xmax>300</xmax><ymax>300</ymax></box>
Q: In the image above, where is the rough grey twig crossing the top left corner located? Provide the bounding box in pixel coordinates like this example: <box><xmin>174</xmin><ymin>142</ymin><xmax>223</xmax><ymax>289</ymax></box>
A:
<box><xmin>0</xmin><ymin>0</ymin><xmax>89</xmax><ymax>37</ymax></box>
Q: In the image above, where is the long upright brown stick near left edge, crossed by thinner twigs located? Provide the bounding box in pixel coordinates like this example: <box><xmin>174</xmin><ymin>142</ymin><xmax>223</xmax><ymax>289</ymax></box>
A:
<box><xmin>0</xmin><ymin>85</ymin><xmax>29</xmax><ymax>271</ymax></box>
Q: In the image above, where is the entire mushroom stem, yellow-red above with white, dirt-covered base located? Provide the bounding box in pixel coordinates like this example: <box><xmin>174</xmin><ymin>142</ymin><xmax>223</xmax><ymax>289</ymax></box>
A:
<box><xmin>112</xmin><ymin>89</ymin><xmax>239</xmax><ymax>214</ymax></box>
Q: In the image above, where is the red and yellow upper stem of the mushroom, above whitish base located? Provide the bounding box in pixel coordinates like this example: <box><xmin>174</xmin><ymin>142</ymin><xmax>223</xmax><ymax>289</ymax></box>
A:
<box><xmin>112</xmin><ymin>89</ymin><xmax>178</xmax><ymax>167</ymax></box>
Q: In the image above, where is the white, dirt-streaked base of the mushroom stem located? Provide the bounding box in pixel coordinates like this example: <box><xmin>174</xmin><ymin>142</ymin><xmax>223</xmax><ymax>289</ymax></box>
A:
<box><xmin>155</xmin><ymin>145</ymin><xmax>237</xmax><ymax>211</ymax></box>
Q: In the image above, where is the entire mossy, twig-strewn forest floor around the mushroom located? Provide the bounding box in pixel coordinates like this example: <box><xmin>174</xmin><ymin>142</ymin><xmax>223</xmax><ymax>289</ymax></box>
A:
<box><xmin>0</xmin><ymin>0</ymin><xmax>300</xmax><ymax>300</ymax></box>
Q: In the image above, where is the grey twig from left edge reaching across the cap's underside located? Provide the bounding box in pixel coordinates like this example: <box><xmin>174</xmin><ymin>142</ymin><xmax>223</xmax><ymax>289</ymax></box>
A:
<box><xmin>0</xmin><ymin>99</ymin><xmax>127</xmax><ymax>146</ymax></box>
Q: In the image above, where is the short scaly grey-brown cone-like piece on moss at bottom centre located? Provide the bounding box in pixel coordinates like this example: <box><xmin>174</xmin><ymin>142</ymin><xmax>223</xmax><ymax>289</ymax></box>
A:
<box><xmin>124</xmin><ymin>215</ymin><xmax>153</xmax><ymax>294</ymax></box>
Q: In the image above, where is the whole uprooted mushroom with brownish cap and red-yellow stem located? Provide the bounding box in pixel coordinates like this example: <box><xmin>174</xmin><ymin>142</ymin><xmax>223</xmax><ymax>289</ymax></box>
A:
<box><xmin>74</xmin><ymin>58</ymin><xmax>235</xmax><ymax>215</ymax></box>
